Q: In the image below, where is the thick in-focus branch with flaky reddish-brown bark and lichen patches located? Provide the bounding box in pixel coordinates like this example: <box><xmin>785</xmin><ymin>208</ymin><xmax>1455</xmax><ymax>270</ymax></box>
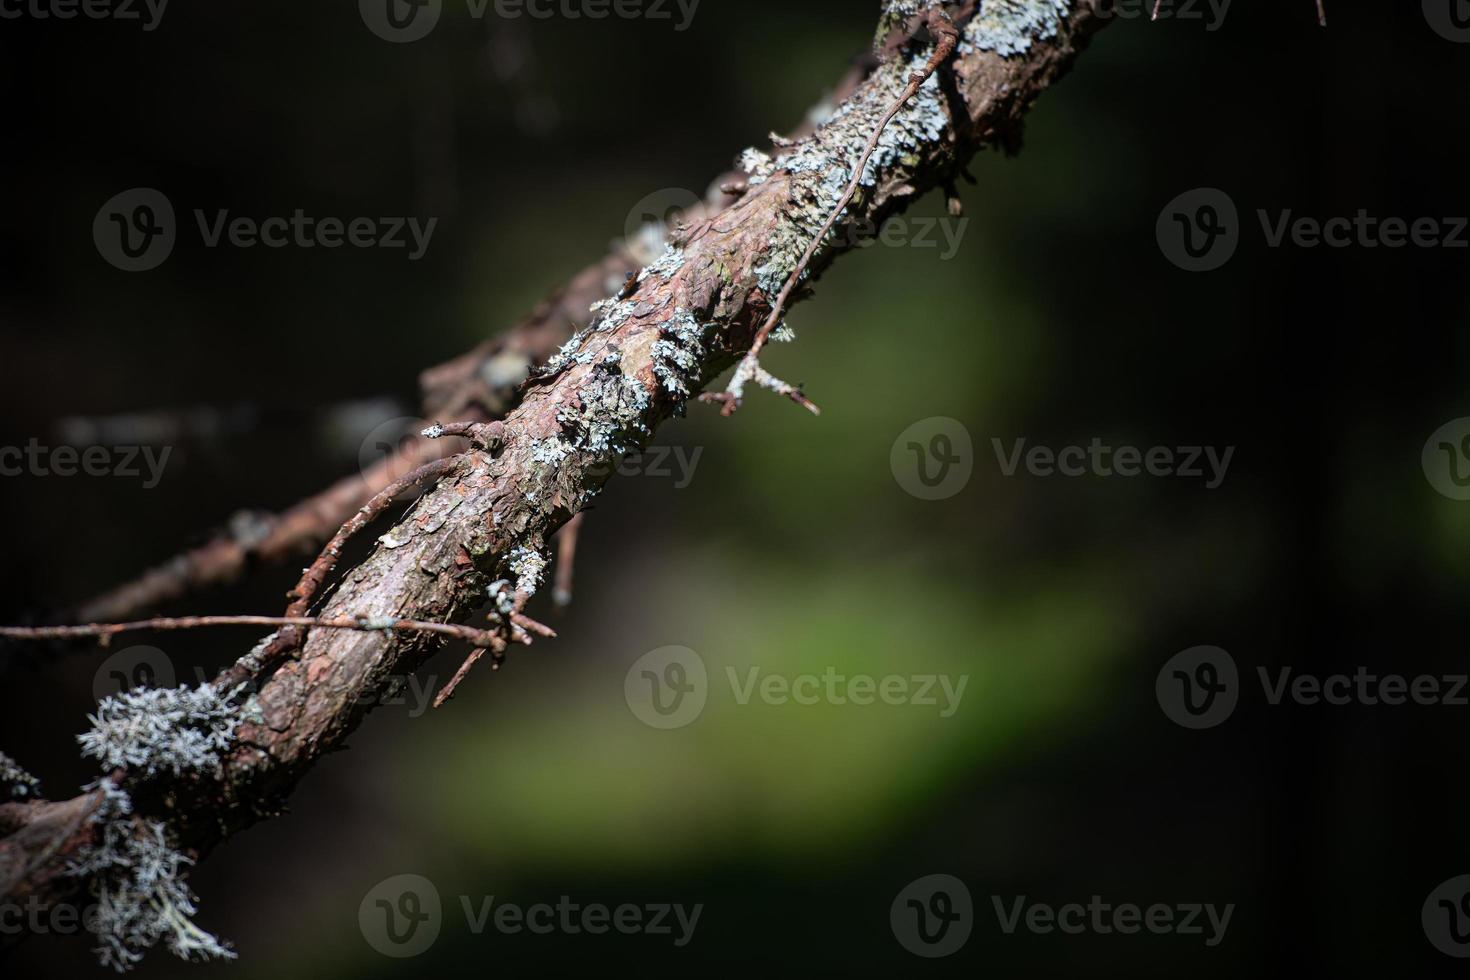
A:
<box><xmin>0</xmin><ymin>0</ymin><xmax>1105</xmax><ymax>963</ymax></box>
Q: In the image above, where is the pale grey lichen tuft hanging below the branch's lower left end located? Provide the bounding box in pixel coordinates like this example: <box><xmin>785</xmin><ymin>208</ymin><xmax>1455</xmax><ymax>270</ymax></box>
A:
<box><xmin>68</xmin><ymin>779</ymin><xmax>235</xmax><ymax>973</ymax></box>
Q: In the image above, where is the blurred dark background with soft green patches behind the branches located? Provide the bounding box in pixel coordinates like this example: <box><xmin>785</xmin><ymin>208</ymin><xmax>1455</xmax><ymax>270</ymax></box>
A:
<box><xmin>0</xmin><ymin>0</ymin><xmax>1470</xmax><ymax>980</ymax></box>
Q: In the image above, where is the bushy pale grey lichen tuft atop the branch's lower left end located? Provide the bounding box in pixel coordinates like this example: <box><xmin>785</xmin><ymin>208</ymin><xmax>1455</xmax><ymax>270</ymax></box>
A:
<box><xmin>76</xmin><ymin>683</ymin><xmax>259</xmax><ymax>776</ymax></box>
